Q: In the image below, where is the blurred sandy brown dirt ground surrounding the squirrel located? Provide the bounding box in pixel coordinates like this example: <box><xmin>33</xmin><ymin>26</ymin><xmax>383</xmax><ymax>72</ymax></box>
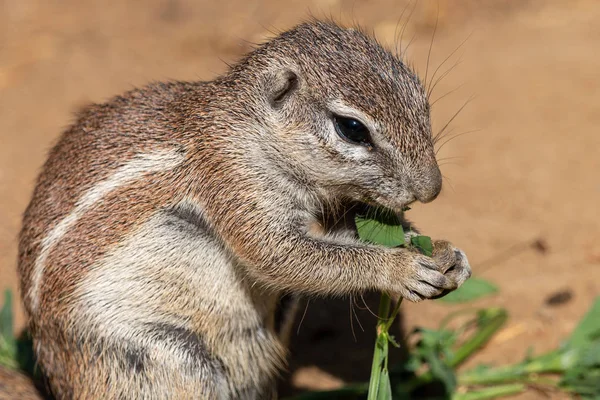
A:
<box><xmin>0</xmin><ymin>0</ymin><xmax>600</xmax><ymax>398</ymax></box>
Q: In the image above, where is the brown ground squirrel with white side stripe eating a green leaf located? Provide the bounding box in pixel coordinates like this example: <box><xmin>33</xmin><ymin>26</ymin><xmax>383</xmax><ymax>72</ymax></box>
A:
<box><xmin>14</xmin><ymin>21</ymin><xmax>470</xmax><ymax>399</ymax></box>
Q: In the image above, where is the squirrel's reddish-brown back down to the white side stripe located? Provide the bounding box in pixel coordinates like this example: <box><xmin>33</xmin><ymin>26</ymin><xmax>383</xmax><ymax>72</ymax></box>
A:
<box><xmin>19</xmin><ymin>82</ymin><xmax>200</xmax><ymax>315</ymax></box>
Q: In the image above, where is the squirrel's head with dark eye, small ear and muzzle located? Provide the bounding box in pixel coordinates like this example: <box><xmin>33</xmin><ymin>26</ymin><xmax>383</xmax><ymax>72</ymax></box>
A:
<box><xmin>227</xmin><ymin>22</ymin><xmax>442</xmax><ymax>211</ymax></box>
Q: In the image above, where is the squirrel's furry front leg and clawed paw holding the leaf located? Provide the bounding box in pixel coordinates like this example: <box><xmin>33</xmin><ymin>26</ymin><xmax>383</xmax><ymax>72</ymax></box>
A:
<box><xmin>217</xmin><ymin>203</ymin><xmax>463</xmax><ymax>301</ymax></box>
